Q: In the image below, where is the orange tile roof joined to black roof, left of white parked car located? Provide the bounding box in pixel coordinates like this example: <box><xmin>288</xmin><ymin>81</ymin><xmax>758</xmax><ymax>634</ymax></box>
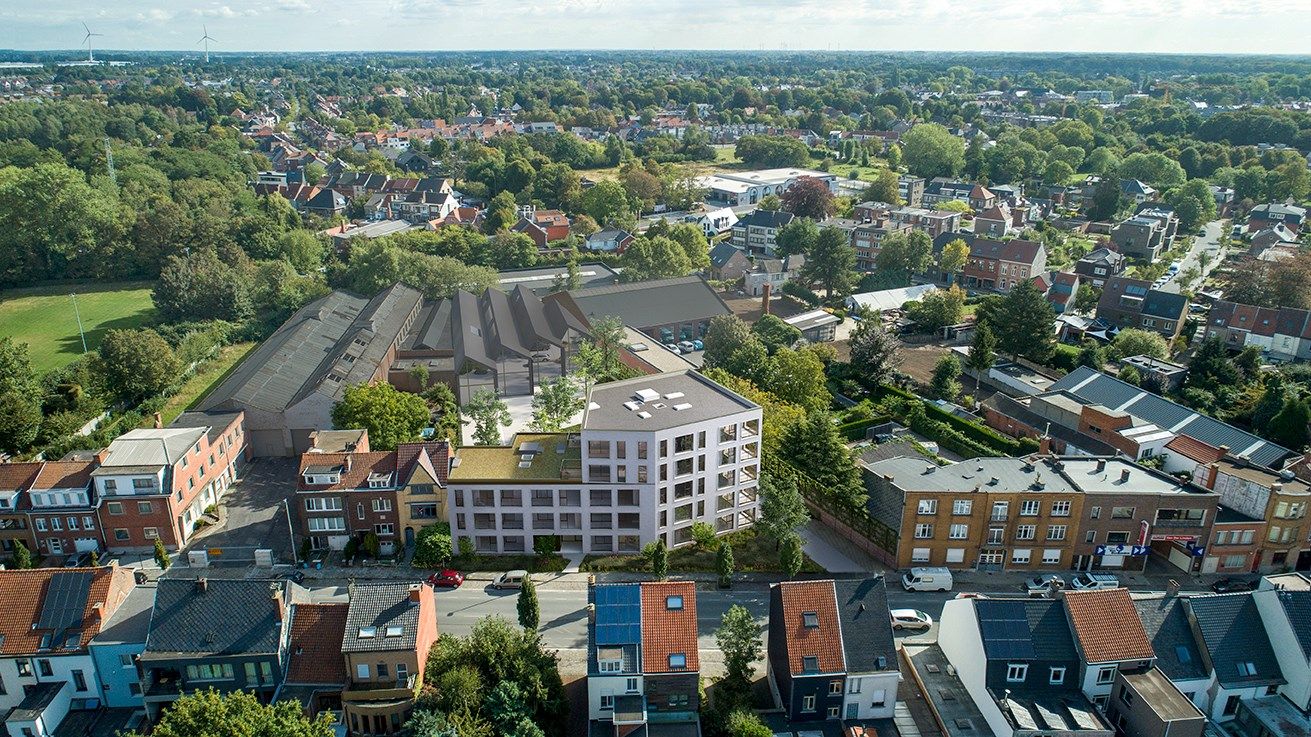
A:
<box><xmin>771</xmin><ymin>581</ymin><xmax>847</xmax><ymax>675</ymax></box>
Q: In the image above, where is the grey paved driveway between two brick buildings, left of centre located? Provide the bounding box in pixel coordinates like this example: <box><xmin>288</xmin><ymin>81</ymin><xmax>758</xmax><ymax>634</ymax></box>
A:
<box><xmin>187</xmin><ymin>458</ymin><xmax>299</xmax><ymax>564</ymax></box>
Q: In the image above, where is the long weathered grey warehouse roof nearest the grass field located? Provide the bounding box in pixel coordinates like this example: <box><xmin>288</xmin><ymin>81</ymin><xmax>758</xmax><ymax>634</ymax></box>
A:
<box><xmin>201</xmin><ymin>285</ymin><xmax>423</xmax><ymax>412</ymax></box>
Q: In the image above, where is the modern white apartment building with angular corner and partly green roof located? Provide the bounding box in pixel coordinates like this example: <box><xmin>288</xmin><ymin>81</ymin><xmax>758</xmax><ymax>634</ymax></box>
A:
<box><xmin>447</xmin><ymin>371</ymin><xmax>762</xmax><ymax>553</ymax></box>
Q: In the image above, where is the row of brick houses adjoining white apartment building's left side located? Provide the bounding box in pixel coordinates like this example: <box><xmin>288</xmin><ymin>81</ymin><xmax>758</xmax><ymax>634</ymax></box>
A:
<box><xmin>296</xmin><ymin>431</ymin><xmax>450</xmax><ymax>555</ymax></box>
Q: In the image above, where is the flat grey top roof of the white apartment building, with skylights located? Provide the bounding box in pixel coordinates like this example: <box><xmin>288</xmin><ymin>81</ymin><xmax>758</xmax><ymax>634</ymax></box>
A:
<box><xmin>582</xmin><ymin>371</ymin><xmax>760</xmax><ymax>431</ymax></box>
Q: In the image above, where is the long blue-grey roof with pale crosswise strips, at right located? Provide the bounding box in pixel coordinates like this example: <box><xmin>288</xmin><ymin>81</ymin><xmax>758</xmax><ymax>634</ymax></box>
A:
<box><xmin>1050</xmin><ymin>366</ymin><xmax>1295</xmax><ymax>469</ymax></box>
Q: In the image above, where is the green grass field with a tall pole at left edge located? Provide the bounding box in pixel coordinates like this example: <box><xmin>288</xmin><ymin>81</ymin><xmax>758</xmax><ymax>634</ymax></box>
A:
<box><xmin>0</xmin><ymin>282</ymin><xmax>155</xmax><ymax>372</ymax></box>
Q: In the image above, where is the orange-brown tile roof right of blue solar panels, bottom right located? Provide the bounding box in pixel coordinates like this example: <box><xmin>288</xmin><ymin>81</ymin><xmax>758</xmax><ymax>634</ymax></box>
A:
<box><xmin>1065</xmin><ymin>589</ymin><xmax>1156</xmax><ymax>662</ymax></box>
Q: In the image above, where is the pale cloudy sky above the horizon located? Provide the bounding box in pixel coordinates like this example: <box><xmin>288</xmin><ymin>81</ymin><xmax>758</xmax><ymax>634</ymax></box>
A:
<box><xmin>0</xmin><ymin>0</ymin><xmax>1311</xmax><ymax>54</ymax></box>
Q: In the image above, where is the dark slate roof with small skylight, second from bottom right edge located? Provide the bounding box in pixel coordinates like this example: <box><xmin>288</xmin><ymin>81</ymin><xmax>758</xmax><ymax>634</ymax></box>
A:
<box><xmin>1185</xmin><ymin>591</ymin><xmax>1285</xmax><ymax>688</ymax></box>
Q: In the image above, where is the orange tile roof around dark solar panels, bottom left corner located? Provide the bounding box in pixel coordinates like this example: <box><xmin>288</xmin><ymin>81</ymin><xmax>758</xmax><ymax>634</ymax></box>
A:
<box><xmin>0</xmin><ymin>565</ymin><xmax>132</xmax><ymax>656</ymax></box>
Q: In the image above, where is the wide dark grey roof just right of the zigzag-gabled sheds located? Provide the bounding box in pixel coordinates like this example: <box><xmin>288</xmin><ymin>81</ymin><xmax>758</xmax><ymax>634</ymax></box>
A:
<box><xmin>552</xmin><ymin>277</ymin><xmax>732</xmax><ymax>328</ymax></box>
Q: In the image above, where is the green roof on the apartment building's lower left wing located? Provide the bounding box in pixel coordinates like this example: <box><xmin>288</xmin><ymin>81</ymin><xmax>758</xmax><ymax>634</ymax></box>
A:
<box><xmin>447</xmin><ymin>433</ymin><xmax>582</xmax><ymax>484</ymax></box>
